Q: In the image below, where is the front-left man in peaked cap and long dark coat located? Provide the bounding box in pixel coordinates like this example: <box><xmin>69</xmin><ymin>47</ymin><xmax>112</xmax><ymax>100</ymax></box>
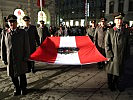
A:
<box><xmin>1</xmin><ymin>14</ymin><xmax>30</xmax><ymax>96</ymax></box>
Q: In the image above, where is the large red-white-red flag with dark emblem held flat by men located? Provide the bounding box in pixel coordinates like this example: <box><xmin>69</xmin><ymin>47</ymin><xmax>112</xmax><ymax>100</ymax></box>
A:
<box><xmin>30</xmin><ymin>36</ymin><xmax>107</xmax><ymax>65</ymax></box>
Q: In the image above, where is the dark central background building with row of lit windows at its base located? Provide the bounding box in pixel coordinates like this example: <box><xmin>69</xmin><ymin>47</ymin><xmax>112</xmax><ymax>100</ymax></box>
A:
<box><xmin>55</xmin><ymin>0</ymin><xmax>106</xmax><ymax>26</ymax></box>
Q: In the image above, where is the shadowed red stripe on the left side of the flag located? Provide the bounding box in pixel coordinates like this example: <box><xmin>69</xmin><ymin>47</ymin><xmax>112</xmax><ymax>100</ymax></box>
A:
<box><xmin>30</xmin><ymin>37</ymin><xmax>60</xmax><ymax>63</ymax></box>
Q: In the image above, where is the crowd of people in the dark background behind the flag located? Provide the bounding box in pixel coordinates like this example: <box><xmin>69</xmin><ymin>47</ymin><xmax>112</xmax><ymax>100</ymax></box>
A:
<box><xmin>0</xmin><ymin>16</ymin><xmax>133</xmax><ymax>36</ymax></box>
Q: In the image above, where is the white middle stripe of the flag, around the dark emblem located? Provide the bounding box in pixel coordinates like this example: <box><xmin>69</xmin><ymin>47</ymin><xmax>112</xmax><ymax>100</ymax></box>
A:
<box><xmin>55</xmin><ymin>37</ymin><xmax>80</xmax><ymax>65</ymax></box>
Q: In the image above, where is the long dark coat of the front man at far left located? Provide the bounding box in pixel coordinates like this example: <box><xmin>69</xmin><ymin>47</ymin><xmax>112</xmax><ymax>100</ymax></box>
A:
<box><xmin>1</xmin><ymin>28</ymin><xmax>30</xmax><ymax>77</ymax></box>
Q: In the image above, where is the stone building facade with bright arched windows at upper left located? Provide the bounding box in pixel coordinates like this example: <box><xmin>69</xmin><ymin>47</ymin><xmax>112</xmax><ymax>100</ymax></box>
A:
<box><xmin>0</xmin><ymin>0</ymin><xmax>56</xmax><ymax>27</ymax></box>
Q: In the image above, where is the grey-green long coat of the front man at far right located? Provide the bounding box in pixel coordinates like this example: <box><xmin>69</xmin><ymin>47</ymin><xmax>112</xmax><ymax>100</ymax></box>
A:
<box><xmin>105</xmin><ymin>27</ymin><xmax>127</xmax><ymax>76</ymax></box>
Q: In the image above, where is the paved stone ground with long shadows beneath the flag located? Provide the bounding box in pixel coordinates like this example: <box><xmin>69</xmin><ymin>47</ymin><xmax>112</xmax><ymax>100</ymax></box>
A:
<box><xmin>0</xmin><ymin>57</ymin><xmax>133</xmax><ymax>100</ymax></box>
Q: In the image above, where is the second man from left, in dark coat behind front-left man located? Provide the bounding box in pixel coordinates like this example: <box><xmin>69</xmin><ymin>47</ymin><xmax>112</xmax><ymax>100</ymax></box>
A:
<box><xmin>23</xmin><ymin>16</ymin><xmax>40</xmax><ymax>73</ymax></box>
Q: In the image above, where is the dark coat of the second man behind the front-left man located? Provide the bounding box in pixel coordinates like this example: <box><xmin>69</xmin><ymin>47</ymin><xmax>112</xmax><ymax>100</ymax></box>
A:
<box><xmin>24</xmin><ymin>25</ymin><xmax>40</xmax><ymax>54</ymax></box>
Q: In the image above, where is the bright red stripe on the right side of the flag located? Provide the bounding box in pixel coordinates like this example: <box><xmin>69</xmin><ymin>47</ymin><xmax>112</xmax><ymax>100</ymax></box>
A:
<box><xmin>75</xmin><ymin>36</ymin><xmax>107</xmax><ymax>64</ymax></box>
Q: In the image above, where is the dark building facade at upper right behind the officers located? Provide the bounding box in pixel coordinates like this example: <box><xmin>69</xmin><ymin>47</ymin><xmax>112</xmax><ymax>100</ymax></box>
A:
<box><xmin>105</xmin><ymin>0</ymin><xmax>133</xmax><ymax>26</ymax></box>
